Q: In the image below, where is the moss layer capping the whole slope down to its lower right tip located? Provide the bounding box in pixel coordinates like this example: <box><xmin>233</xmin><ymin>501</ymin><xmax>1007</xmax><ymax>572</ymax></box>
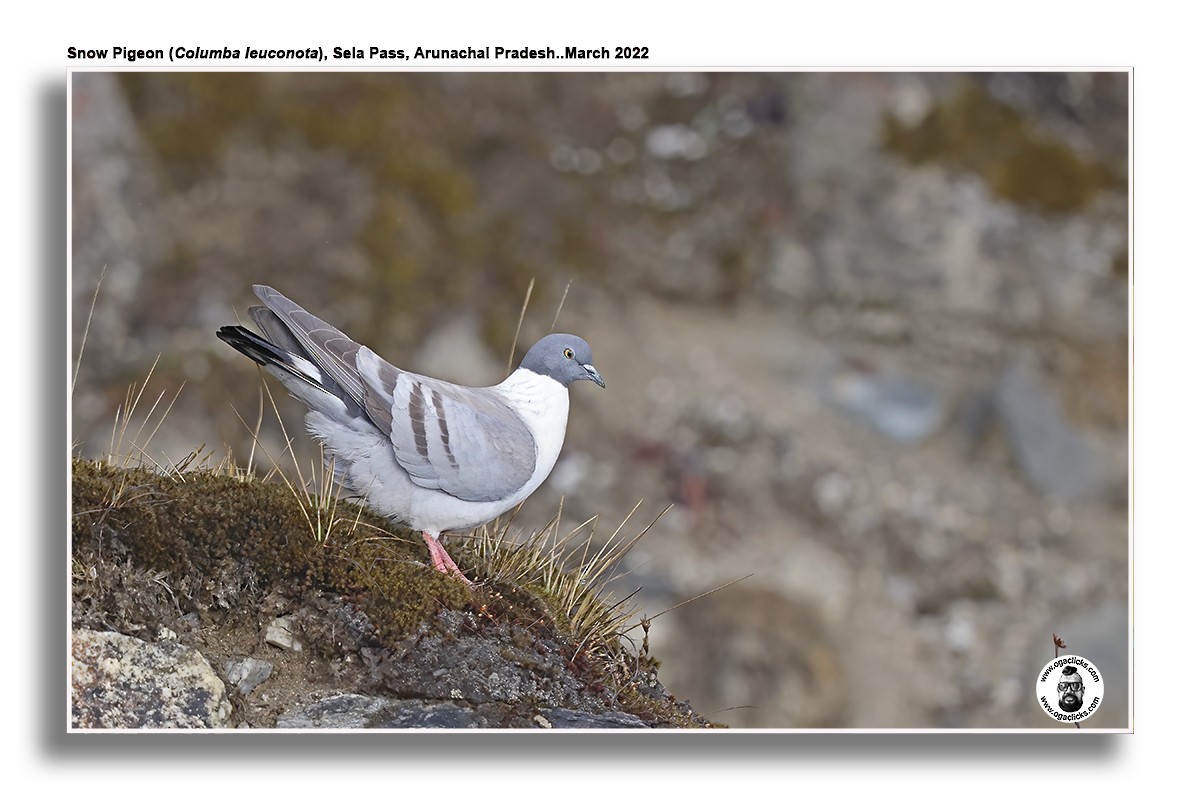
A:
<box><xmin>72</xmin><ymin>459</ymin><xmax>709</xmax><ymax>727</ymax></box>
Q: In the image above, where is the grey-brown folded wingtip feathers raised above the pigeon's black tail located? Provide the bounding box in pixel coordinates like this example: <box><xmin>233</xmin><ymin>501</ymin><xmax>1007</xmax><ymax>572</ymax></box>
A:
<box><xmin>250</xmin><ymin>285</ymin><xmax>366</xmax><ymax>408</ymax></box>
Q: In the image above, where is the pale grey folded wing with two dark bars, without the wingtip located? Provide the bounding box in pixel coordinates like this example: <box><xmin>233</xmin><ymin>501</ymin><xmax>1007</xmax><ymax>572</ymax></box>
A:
<box><xmin>358</xmin><ymin>347</ymin><xmax>538</xmax><ymax>503</ymax></box>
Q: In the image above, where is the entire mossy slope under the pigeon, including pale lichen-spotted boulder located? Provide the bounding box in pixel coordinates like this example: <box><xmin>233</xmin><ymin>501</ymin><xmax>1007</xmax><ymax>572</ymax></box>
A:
<box><xmin>71</xmin><ymin>461</ymin><xmax>710</xmax><ymax>728</ymax></box>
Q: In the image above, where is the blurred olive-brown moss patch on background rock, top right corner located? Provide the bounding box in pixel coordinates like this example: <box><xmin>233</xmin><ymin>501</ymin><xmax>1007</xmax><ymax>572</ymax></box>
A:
<box><xmin>883</xmin><ymin>82</ymin><xmax>1124</xmax><ymax>212</ymax></box>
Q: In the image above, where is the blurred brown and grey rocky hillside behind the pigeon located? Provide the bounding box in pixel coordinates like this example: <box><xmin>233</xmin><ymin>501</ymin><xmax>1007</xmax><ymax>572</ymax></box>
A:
<box><xmin>70</xmin><ymin>72</ymin><xmax>1129</xmax><ymax>728</ymax></box>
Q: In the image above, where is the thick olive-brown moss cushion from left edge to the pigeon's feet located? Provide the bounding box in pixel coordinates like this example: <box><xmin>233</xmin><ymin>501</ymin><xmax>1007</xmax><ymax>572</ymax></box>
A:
<box><xmin>72</xmin><ymin>459</ymin><xmax>474</xmax><ymax>642</ymax></box>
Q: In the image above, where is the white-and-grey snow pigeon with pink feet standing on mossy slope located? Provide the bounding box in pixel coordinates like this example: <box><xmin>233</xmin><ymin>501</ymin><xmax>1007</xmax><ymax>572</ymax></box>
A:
<box><xmin>217</xmin><ymin>285</ymin><xmax>605</xmax><ymax>584</ymax></box>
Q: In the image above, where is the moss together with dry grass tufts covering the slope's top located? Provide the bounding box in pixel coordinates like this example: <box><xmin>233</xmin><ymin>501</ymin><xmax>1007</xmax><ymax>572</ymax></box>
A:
<box><xmin>71</xmin><ymin>369</ymin><xmax>707</xmax><ymax>726</ymax></box>
